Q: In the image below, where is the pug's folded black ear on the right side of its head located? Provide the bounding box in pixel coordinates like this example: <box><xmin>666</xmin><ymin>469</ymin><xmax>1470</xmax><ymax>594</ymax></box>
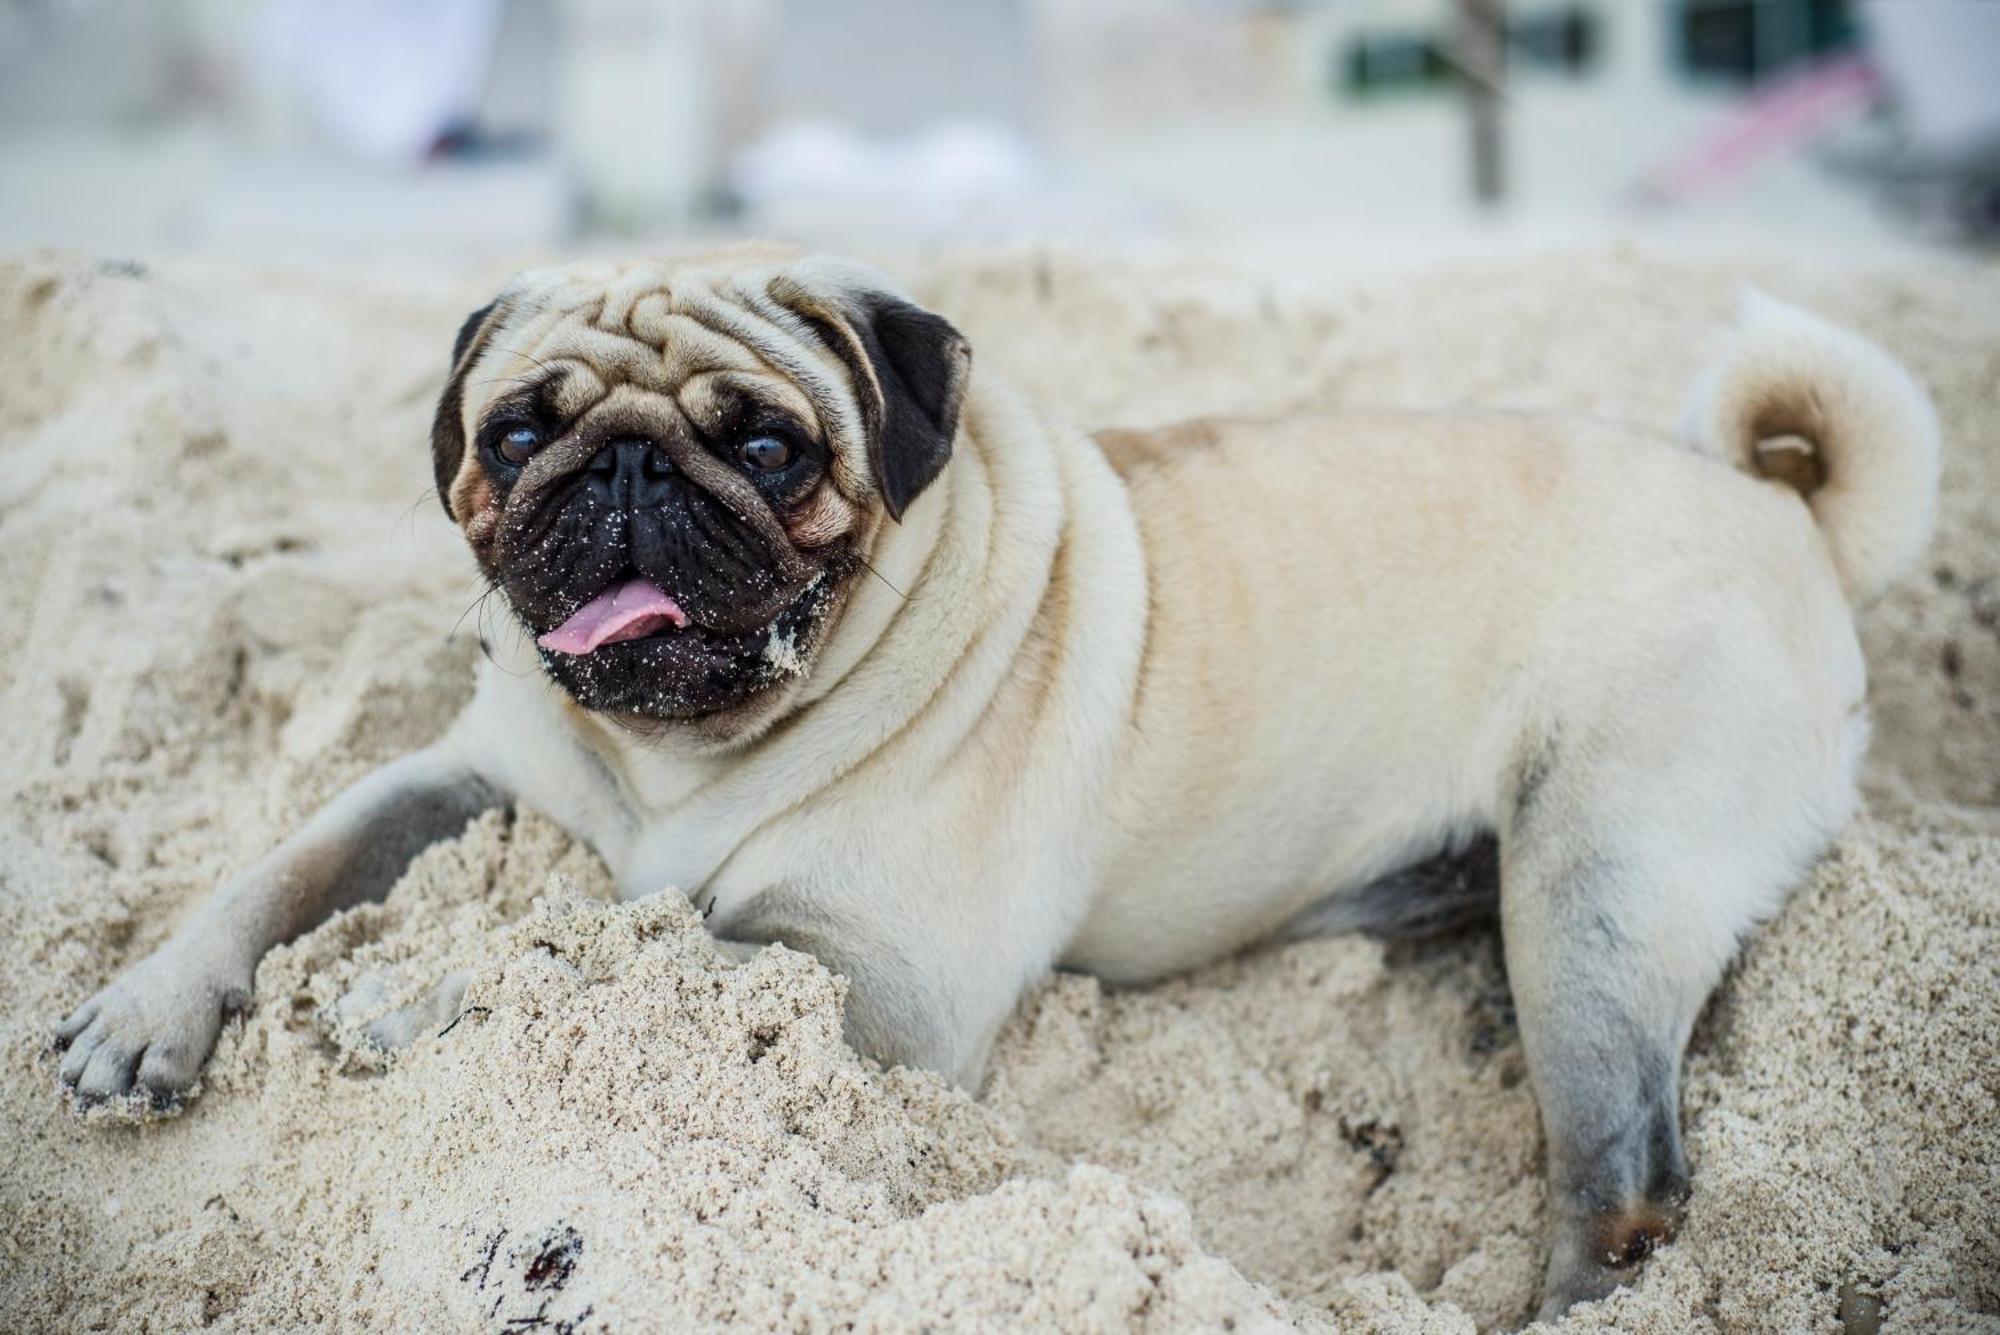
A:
<box><xmin>772</xmin><ymin>280</ymin><xmax>972</xmax><ymax>520</ymax></box>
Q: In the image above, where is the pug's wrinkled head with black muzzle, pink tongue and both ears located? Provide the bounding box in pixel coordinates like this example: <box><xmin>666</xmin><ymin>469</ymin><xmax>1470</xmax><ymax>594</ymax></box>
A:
<box><xmin>432</xmin><ymin>250</ymin><xmax>970</xmax><ymax>739</ymax></box>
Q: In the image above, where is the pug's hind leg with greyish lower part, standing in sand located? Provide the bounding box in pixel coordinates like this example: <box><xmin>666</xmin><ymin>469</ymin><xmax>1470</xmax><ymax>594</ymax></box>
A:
<box><xmin>1500</xmin><ymin>703</ymin><xmax>1846</xmax><ymax>1319</ymax></box>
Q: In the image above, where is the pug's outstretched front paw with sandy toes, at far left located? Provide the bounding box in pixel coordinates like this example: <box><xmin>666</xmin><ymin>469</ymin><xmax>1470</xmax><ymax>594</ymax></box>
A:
<box><xmin>56</xmin><ymin>939</ymin><xmax>250</xmax><ymax>1111</ymax></box>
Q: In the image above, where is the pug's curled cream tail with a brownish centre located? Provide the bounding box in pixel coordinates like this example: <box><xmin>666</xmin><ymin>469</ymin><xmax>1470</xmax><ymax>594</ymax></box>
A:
<box><xmin>1684</xmin><ymin>288</ymin><xmax>1938</xmax><ymax>606</ymax></box>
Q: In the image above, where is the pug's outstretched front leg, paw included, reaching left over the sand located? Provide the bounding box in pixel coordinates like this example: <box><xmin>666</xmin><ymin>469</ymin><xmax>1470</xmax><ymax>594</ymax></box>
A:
<box><xmin>56</xmin><ymin>743</ymin><xmax>504</xmax><ymax>1107</ymax></box>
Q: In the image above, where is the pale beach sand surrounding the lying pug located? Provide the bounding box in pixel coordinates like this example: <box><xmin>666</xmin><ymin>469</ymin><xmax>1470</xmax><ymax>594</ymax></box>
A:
<box><xmin>0</xmin><ymin>254</ymin><xmax>2000</xmax><ymax>1333</ymax></box>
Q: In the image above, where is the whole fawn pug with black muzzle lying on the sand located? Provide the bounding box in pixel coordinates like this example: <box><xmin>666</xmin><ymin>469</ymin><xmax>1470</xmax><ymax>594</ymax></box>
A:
<box><xmin>58</xmin><ymin>248</ymin><xmax>1938</xmax><ymax>1315</ymax></box>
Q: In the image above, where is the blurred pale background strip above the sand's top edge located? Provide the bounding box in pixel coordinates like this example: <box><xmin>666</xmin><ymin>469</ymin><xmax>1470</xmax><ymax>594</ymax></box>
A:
<box><xmin>0</xmin><ymin>0</ymin><xmax>2000</xmax><ymax>270</ymax></box>
